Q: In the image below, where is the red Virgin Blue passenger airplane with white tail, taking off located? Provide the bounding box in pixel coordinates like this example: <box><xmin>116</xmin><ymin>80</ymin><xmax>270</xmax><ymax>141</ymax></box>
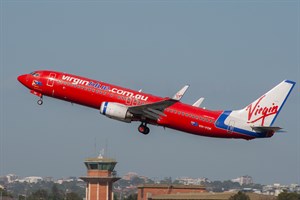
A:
<box><xmin>17</xmin><ymin>70</ymin><xmax>296</xmax><ymax>140</ymax></box>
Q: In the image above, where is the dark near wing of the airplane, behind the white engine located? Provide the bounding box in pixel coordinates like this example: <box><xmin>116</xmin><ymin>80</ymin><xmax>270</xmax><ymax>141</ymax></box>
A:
<box><xmin>128</xmin><ymin>98</ymin><xmax>178</xmax><ymax>120</ymax></box>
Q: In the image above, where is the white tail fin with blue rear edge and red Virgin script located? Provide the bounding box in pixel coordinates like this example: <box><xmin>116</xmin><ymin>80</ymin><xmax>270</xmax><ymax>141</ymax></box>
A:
<box><xmin>234</xmin><ymin>80</ymin><xmax>296</xmax><ymax>127</ymax></box>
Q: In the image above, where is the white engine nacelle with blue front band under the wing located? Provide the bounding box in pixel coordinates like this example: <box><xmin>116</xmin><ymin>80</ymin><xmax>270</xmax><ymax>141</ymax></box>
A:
<box><xmin>100</xmin><ymin>102</ymin><xmax>133</xmax><ymax>123</ymax></box>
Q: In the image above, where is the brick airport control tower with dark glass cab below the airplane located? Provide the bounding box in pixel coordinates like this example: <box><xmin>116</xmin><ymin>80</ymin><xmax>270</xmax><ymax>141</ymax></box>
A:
<box><xmin>80</xmin><ymin>154</ymin><xmax>120</xmax><ymax>200</ymax></box>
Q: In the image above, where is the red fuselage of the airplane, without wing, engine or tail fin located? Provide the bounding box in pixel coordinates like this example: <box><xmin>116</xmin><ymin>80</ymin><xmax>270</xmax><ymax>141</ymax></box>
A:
<box><xmin>18</xmin><ymin>71</ymin><xmax>272</xmax><ymax>140</ymax></box>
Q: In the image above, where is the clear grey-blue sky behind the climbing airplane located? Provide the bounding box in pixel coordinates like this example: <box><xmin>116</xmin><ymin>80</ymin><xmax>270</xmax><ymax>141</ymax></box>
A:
<box><xmin>0</xmin><ymin>0</ymin><xmax>300</xmax><ymax>184</ymax></box>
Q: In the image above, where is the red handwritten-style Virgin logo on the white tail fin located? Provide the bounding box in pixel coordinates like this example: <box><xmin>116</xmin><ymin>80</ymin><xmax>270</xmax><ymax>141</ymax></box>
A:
<box><xmin>246</xmin><ymin>95</ymin><xmax>278</xmax><ymax>126</ymax></box>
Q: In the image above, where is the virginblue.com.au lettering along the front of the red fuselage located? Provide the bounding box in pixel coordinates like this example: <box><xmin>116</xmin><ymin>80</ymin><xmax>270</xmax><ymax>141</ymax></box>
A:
<box><xmin>62</xmin><ymin>75</ymin><xmax>148</xmax><ymax>101</ymax></box>
